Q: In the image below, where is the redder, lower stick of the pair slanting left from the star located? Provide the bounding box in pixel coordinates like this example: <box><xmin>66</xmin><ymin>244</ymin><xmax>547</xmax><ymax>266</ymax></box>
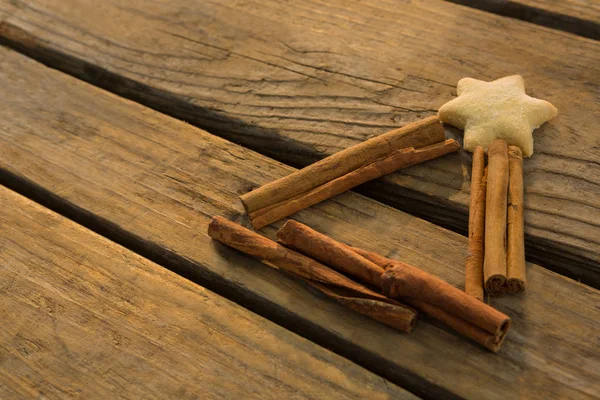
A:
<box><xmin>250</xmin><ymin>139</ymin><xmax>460</xmax><ymax>229</ymax></box>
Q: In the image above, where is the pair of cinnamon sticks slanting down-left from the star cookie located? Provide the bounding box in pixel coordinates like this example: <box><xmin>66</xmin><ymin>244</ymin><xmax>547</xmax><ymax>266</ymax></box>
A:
<box><xmin>240</xmin><ymin>117</ymin><xmax>460</xmax><ymax>229</ymax></box>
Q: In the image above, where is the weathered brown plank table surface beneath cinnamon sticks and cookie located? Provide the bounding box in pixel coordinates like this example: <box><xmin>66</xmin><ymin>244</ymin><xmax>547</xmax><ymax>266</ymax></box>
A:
<box><xmin>0</xmin><ymin>0</ymin><xmax>600</xmax><ymax>399</ymax></box>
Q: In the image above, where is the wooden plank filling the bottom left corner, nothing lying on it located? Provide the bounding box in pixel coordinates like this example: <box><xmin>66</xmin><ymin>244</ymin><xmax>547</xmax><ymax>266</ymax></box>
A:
<box><xmin>0</xmin><ymin>186</ymin><xmax>416</xmax><ymax>400</ymax></box>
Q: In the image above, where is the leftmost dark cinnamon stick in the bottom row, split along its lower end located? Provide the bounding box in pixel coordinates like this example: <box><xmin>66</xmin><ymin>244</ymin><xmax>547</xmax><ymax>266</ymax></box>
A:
<box><xmin>208</xmin><ymin>216</ymin><xmax>417</xmax><ymax>331</ymax></box>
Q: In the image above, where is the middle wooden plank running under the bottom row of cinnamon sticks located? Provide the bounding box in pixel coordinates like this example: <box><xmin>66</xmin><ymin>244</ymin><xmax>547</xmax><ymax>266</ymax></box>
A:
<box><xmin>0</xmin><ymin>49</ymin><xmax>600</xmax><ymax>399</ymax></box>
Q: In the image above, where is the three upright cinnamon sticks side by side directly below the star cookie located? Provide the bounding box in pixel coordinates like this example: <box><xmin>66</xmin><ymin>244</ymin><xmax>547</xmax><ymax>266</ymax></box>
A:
<box><xmin>465</xmin><ymin>139</ymin><xmax>527</xmax><ymax>300</ymax></box>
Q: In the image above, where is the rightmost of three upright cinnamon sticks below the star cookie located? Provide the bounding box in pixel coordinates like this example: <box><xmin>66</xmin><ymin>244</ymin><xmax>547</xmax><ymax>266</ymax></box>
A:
<box><xmin>506</xmin><ymin>146</ymin><xmax>527</xmax><ymax>294</ymax></box>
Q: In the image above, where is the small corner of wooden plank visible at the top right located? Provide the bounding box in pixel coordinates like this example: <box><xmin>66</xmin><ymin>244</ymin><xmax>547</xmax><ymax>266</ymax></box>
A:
<box><xmin>448</xmin><ymin>0</ymin><xmax>600</xmax><ymax>40</ymax></box>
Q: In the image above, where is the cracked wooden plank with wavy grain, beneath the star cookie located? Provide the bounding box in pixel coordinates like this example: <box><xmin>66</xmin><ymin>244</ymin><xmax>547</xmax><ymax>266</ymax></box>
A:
<box><xmin>0</xmin><ymin>0</ymin><xmax>600</xmax><ymax>287</ymax></box>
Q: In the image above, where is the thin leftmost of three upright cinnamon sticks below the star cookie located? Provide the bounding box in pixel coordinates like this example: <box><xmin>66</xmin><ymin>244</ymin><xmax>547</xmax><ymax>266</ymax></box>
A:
<box><xmin>465</xmin><ymin>146</ymin><xmax>486</xmax><ymax>301</ymax></box>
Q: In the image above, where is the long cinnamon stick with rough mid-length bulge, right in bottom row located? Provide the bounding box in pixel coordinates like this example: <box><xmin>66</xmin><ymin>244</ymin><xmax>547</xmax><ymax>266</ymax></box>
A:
<box><xmin>277</xmin><ymin>220</ymin><xmax>510</xmax><ymax>351</ymax></box>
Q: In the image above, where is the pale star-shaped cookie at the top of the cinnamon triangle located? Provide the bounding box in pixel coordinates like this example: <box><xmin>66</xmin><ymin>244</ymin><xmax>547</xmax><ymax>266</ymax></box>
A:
<box><xmin>438</xmin><ymin>75</ymin><xmax>558</xmax><ymax>157</ymax></box>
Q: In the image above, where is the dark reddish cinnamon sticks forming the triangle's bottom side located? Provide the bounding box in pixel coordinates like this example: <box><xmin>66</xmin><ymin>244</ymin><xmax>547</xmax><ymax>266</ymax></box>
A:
<box><xmin>208</xmin><ymin>217</ymin><xmax>510</xmax><ymax>352</ymax></box>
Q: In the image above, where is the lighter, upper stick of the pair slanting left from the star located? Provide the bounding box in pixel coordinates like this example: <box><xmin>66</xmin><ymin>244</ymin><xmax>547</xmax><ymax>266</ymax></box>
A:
<box><xmin>240</xmin><ymin>117</ymin><xmax>445</xmax><ymax>225</ymax></box>
